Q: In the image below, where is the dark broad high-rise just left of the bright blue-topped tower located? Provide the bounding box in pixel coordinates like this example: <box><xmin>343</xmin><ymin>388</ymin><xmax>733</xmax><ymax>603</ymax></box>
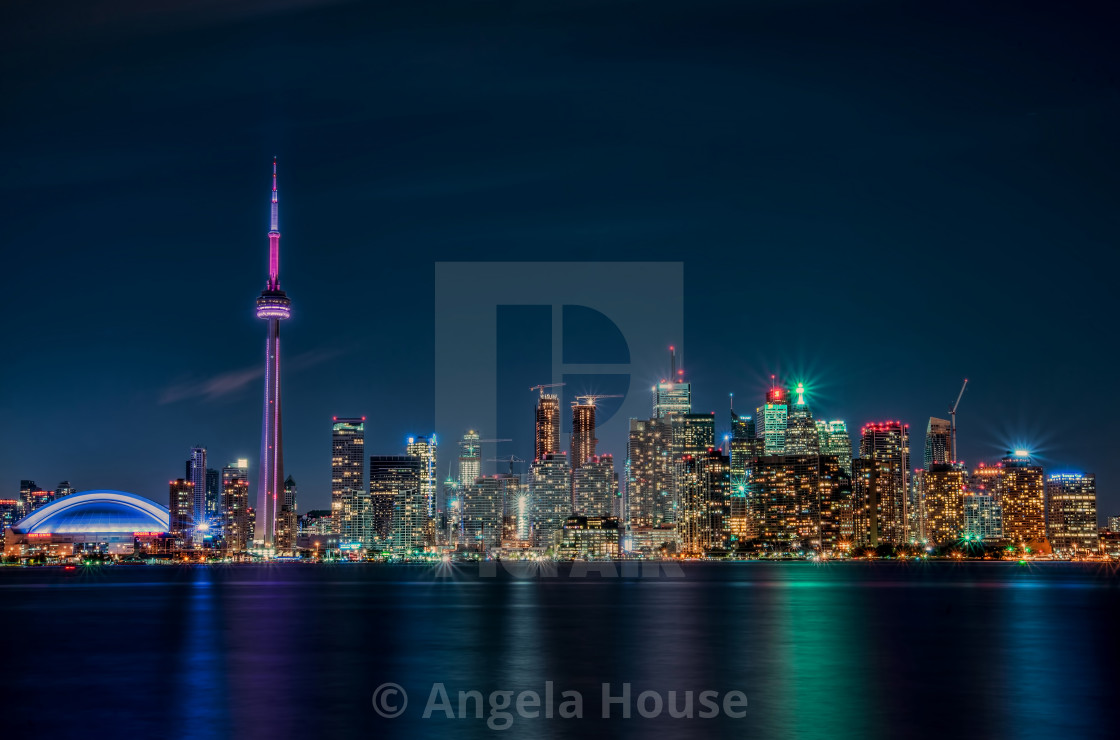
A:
<box><xmin>370</xmin><ymin>455</ymin><xmax>424</xmax><ymax>552</ymax></box>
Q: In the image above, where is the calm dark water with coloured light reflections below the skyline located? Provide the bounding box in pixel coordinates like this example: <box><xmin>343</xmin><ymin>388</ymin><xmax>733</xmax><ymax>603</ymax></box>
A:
<box><xmin>0</xmin><ymin>563</ymin><xmax>1120</xmax><ymax>740</ymax></box>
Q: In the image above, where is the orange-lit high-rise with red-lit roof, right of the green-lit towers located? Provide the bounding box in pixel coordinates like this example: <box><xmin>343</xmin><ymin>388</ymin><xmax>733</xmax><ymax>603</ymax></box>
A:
<box><xmin>852</xmin><ymin>421</ymin><xmax>911</xmax><ymax>545</ymax></box>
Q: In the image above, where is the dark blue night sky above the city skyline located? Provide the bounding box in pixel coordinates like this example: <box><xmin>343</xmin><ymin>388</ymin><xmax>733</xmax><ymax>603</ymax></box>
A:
<box><xmin>0</xmin><ymin>0</ymin><xmax>1120</xmax><ymax>517</ymax></box>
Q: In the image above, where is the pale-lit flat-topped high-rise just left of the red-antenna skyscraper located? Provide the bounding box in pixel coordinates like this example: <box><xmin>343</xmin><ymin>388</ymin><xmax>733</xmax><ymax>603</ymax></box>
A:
<box><xmin>627</xmin><ymin>419</ymin><xmax>674</xmax><ymax>527</ymax></box>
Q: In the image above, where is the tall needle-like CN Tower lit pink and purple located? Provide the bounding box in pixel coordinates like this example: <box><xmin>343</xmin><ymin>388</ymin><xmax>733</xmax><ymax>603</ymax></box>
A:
<box><xmin>253</xmin><ymin>159</ymin><xmax>291</xmax><ymax>549</ymax></box>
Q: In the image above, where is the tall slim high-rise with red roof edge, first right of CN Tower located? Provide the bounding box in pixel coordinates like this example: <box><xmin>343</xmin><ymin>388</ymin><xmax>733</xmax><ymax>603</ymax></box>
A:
<box><xmin>331</xmin><ymin>416</ymin><xmax>374</xmax><ymax>549</ymax></box>
